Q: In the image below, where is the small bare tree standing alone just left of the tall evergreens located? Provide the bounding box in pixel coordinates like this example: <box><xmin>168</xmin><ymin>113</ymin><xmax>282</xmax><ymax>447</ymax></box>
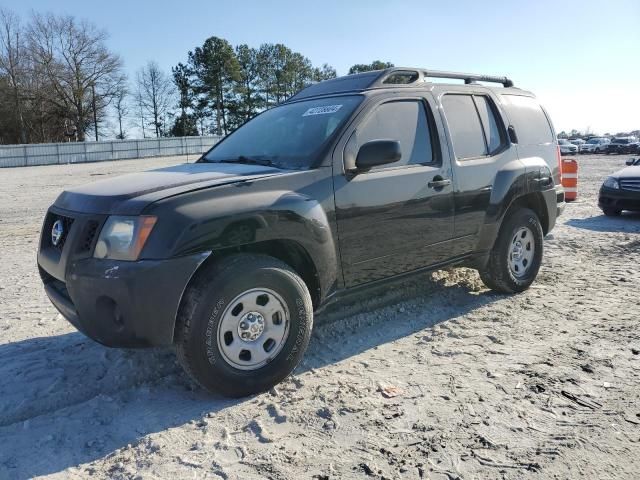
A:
<box><xmin>137</xmin><ymin>61</ymin><xmax>175</xmax><ymax>137</ymax></box>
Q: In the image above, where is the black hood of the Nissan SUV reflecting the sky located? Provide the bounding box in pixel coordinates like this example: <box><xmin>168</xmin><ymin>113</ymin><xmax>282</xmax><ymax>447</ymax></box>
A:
<box><xmin>54</xmin><ymin>163</ymin><xmax>285</xmax><ymax>215</ymax></box>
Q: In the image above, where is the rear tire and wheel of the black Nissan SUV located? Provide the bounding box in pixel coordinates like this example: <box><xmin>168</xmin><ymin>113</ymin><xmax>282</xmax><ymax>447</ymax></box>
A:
<box><xmin>480</xmin><ymin>208</ymin><xmax>543</xmax><ymax>293</ymax></box>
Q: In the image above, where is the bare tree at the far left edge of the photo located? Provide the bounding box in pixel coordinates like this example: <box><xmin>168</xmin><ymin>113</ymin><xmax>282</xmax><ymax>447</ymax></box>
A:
<box><xmin>0</xmin><ymin>8</ymin><xmax>27</xmax><ymax>143</ymax></box>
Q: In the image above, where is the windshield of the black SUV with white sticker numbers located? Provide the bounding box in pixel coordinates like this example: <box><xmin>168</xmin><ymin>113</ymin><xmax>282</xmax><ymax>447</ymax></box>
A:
<box><xmin>201</xmin><ymin>95</ymin><xmax>363</xmax><ymax>169</ymax></box>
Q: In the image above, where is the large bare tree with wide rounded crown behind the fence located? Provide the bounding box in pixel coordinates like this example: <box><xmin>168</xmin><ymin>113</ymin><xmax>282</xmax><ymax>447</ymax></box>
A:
<box><xmin>29</xmin><ymin>14</ymin><xmax>122</xmax><ymax>141</ymax></box>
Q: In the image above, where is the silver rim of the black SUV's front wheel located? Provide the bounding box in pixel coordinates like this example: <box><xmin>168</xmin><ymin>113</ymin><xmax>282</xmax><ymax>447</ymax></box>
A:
<box><xmin>218</xmin><ymin>288</ymin><xmax>289</xmax><ymax>370</ymax></box>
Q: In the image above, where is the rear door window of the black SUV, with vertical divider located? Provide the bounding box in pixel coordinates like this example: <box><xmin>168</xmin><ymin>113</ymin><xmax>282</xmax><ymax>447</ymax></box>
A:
<box><xmin>442</xmin><ymin>94</ymin><xmax>505</xmax><ymax>160</ymax></box>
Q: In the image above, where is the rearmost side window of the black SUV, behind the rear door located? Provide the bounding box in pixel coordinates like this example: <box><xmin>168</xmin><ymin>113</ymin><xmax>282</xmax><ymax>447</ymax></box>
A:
<box><xmin>502</xmin><ymin>94</ymin><xmax>554</xmax><ymax>145</ymax></box>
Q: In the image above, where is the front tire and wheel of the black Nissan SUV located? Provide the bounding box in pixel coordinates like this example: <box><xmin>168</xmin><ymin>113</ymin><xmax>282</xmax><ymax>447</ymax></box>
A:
<box><xmin>176</xmin><ymin>254</ymin><xmax>313</xmax><ymax>397</ymax></box>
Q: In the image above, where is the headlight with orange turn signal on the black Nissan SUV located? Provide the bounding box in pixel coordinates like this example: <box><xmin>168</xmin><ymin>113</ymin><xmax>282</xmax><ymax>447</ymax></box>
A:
<box><xmin>93</xmin><ymin>216</ymin><xmax>157</xmax><ymax>261</ymax></box>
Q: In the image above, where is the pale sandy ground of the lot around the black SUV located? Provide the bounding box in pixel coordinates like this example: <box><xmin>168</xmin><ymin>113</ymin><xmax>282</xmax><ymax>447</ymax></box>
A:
<box><xmin>0</xmin><ymin>156</ymin><xmax>640</xmax><ymax>479</ymax></box>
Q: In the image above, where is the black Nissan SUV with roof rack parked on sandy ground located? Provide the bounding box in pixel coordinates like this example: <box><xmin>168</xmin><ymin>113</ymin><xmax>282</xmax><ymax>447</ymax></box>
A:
<box><xmin>38</xmin><ymin>68</ymin><xmax>564</xmax><ymax>396</ymax></box>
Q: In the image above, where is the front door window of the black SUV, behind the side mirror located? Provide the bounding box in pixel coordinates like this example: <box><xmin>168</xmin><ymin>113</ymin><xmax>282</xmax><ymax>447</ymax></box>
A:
<box><xmin>357</xmin><ymin>100</ymin><xmax>434</xmax><ymax>168</ymax></box>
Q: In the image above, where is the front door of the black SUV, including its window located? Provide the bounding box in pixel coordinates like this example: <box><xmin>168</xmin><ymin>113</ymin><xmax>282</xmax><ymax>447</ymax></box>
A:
<box><xmin>334</xmin><ymin>96</ymin><xmax>453</xmax><ymax>287</ymax></box>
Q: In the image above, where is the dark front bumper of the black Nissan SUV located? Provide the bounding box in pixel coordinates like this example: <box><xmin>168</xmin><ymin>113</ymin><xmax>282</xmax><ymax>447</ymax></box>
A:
<box><xmin>39</xmin><ymin>253</ymin><xmax>209</xmax><ymax>347</ymax></box>
